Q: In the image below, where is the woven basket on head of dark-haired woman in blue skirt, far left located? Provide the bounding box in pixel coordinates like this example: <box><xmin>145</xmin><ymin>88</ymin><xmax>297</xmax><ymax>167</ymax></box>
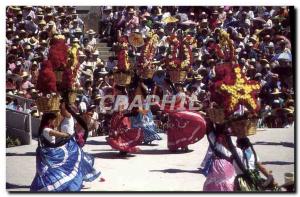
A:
<box><xmin>36</xmin><ymin>96</ymin><xmax>60</xmax><ymax>112</ymax></box>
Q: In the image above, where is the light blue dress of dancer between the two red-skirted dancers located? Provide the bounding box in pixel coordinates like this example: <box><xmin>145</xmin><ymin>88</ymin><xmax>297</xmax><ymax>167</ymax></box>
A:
<box><xmin>130</xmin><ymin>106</ymin><xmax>161</xmax><ymax>144</ymax></box>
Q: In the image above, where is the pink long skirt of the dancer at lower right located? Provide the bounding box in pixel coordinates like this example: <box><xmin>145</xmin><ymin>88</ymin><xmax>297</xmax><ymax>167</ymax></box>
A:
<box><xmin>203</xmin><ymin>158</ymin><xmax>236</xmax><ymax>191</ymax></box>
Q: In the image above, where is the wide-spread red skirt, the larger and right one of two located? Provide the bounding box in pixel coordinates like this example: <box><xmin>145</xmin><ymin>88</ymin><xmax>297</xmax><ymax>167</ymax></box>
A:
<box><xmin>167</xmin><ymin>111</ymin><xmax>206</xmax><ymax>150</ymax></box>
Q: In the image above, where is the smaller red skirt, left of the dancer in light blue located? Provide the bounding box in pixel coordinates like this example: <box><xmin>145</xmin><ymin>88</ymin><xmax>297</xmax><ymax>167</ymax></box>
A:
<box><xmin>106</xmin><ymin>128</ymin><xmax>144</xmax><ymax>153</ymax></box>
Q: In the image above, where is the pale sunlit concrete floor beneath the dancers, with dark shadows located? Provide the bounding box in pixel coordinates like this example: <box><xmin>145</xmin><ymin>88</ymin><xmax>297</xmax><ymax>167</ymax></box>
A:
<box><xmin>6</xmin><ymin>128</ymin><xmax>295</xmax><ymax>191</ymax></box>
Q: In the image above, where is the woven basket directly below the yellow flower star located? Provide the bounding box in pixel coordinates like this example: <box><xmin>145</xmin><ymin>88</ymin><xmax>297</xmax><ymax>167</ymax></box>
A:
<box><xmin>230</xmin><ymin>119</ymin><xmax>258</xmax><ymax>137</ymax></box>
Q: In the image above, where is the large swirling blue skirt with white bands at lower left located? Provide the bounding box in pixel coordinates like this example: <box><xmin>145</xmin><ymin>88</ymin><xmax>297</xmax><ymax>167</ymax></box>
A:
<box><xmin>30</xmin><ymin>138</ymin><xmax>100</xmax><ymax>191</ymax></box>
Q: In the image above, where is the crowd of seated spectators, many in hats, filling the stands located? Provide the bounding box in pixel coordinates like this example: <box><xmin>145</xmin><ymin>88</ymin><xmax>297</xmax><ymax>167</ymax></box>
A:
<box><xmin>6</xmin><ymin>6</ymin><xmax>294</xmax><ymax>134</ymax></box>
